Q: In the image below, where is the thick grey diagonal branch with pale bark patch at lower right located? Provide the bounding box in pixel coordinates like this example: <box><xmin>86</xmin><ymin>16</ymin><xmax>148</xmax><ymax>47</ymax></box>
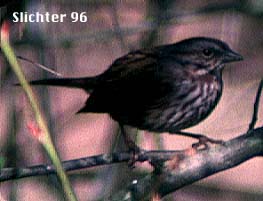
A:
<box><xmin>110</xmin><ymin>127</ymin><xmax>263</xmax><ymax>201</ymax></box>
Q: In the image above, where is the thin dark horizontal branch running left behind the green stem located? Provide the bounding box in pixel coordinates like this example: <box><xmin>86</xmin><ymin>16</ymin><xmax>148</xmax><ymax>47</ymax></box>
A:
<box><xmin>0</xmin><ymin>151</ymin><xmax>184</xmax><ymax>181</ymax></box>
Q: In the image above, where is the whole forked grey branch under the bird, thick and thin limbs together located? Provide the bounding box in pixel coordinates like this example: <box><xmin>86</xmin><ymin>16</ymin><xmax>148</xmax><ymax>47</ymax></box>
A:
<box><xmin>0</xmin><ymin>127</ymin><xmax>263</xmax><ymax>201</ymax></box>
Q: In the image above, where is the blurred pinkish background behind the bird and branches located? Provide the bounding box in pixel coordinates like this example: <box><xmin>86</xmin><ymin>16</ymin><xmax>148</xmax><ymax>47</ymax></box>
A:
<box><xmin>0</xmin><ymin>0</ymin><xmax>263</xmax><ymax>201</ymax></box>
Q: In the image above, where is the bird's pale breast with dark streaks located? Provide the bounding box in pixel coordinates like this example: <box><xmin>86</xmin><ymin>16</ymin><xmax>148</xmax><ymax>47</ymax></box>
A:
<box><xmin>164</xmin><ymin>75</ymin><xmax>222</xmax><ymax>133</ymax></box>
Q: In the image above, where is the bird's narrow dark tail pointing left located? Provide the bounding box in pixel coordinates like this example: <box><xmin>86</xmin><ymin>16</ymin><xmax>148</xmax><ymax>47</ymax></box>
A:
<box><xmin>29</xmin><ymin>76</ymin><xmax>98</xmax><ymax>92</ymax></box>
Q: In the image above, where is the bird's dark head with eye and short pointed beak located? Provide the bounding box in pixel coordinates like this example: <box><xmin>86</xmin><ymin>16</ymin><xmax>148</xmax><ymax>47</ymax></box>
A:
<box><xmin>175</xmin><ymin>37</ymin><xmax>243</xmax><ymax>74</ymax></box>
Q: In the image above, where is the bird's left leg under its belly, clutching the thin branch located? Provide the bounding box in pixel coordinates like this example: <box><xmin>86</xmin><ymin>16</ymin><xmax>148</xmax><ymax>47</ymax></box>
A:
<box><xmin>120</xmin><ymin>124</ymin><xmax>142</xmax><ymax>167</ymax></box>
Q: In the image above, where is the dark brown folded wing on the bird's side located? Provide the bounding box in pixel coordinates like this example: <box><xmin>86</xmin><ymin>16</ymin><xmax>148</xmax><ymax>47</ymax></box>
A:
<box><xmin>77</xmin><ymin>50</ymin><xmax>191</xmax><ymax>118</ymax></box>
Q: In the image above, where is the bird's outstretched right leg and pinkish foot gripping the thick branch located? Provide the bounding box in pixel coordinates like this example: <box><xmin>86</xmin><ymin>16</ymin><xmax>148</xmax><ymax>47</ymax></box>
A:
<box><xmin>176</xmin><ymin>131</ymin><xmax>224</xmax><ymax>149</ymax></box>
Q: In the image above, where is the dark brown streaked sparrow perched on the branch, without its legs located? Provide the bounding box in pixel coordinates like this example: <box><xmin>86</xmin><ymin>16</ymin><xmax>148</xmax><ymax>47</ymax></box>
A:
<box><xmin>30</xmin><ymin>37</ymin><xmax>242</xmax><ymax>143</ymax></box>
